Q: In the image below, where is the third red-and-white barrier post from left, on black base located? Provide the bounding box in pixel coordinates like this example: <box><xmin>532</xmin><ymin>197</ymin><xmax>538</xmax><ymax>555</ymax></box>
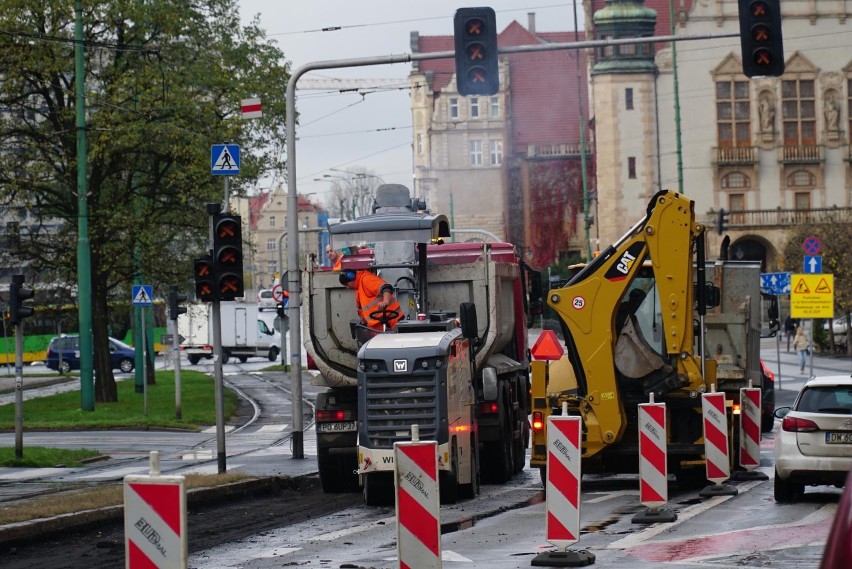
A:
<box><xmin>532</xmin><ymin>404</ymin><xmax>595</xmax><ymax>567</ymax></box>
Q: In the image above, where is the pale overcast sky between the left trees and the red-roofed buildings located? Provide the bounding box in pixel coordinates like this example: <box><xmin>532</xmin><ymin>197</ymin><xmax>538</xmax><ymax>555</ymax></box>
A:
<box><xmin>240</xmin><ymin>0</ymin><xmax>583</xmax><ymax>204</ymax></box>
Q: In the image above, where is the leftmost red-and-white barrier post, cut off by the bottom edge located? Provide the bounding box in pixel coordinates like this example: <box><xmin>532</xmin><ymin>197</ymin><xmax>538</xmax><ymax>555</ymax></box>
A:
<box><xmin>124</xmin><ymin>451</ymin><xmax>188</xmax><ymax>569</ymax></box>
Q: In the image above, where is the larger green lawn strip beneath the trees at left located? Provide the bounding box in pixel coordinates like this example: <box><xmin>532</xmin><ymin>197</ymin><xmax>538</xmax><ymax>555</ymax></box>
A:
<box><xmin>0</xmin><ymin>370</ymin><xmax>237</xmax><ymax>430</ymax></box>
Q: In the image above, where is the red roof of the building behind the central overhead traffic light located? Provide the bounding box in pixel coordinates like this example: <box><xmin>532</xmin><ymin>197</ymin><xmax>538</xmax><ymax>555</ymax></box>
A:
<box><xmin>418</xmin><ymin>21</ymin><xmax>588</xmax><ymax>148</ymax></box>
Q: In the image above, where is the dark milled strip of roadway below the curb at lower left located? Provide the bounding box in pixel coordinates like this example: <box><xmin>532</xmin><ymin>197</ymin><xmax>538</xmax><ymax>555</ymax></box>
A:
<box><xmin>0</xmin><ymin>476</ymin><xmax>362</xmax><ymax>569</ymax></box>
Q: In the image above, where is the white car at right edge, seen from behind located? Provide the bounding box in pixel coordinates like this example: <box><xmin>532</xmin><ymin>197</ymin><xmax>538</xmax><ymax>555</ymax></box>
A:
<box><xmin>775</xmin><ymin>375</ymin><xmax>852</xmax><ymax>502</ymax></box>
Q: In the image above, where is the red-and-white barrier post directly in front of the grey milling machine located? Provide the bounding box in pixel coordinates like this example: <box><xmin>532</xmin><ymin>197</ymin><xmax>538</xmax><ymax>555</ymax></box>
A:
<box><xmin>393</xmin><ymin>425</ymin><xmax>441</xmax><ymax>569</ymax></box>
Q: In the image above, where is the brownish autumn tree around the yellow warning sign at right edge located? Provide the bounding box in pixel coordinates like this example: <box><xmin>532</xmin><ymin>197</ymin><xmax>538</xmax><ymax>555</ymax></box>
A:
<box><xmin>783</xmin><ymin>222</ymin><xmax>852</xmax><ymax>353</ymax></box>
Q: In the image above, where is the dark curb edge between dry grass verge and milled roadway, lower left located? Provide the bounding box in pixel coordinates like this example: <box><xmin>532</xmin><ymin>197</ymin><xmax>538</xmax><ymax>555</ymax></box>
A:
<box><xmin>0</xmin><ymin>475</ymin><xmax>290</xmax><ymax>545</ymax></box>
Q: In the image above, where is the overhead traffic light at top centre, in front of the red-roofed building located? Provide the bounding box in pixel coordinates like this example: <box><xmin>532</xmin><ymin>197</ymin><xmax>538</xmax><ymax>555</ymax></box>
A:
<box><xmin>454</xmin><ymin>8</ymin><xmax>500</xmax><ymax>95</ymax></box>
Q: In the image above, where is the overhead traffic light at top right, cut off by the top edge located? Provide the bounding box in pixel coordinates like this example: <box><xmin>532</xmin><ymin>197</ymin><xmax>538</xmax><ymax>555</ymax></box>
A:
<box><xmin>739</xmin><ymin>0</ymin><xmax>784</xmax><ymax>77</ymax></box>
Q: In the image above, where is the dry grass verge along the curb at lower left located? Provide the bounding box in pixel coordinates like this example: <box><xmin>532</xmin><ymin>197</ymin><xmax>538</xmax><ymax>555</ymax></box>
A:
<box><xmin>0</xmin><ymin>472</ymin><xmax>252</xmax><ymax>525</ymax></box>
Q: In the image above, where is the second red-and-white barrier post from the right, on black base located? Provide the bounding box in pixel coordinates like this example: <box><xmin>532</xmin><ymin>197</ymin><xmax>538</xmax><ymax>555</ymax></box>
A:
<box><xmin>699</xmin><ymin>384</ymin><xmax>737</xmax><ymax>498</ymax></box>
